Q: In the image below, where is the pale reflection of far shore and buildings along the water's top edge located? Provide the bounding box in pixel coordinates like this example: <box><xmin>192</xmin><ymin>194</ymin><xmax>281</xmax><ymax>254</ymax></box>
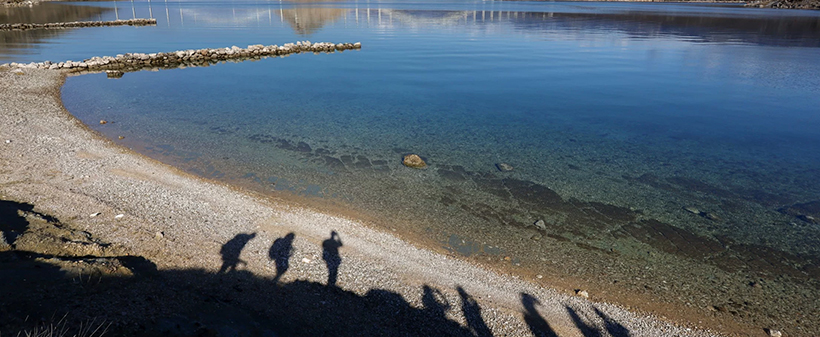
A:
<box><xmin>110</xmin><ymin>0</ymin><xmax>820</xmax><ymax>47</ymax></box>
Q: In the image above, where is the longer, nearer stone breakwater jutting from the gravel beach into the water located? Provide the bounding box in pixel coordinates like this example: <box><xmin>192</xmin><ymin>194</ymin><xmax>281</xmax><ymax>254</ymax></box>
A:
<box><xmin>0</xmin><ymin>41</ymin><xmax>362</xmax><ymax>77</ymax></box>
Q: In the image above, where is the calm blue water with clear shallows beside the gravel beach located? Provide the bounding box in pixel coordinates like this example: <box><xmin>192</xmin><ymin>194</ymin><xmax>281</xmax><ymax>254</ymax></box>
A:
<box><xmin>6</xmin><ymin>1</ymin><xmax>820</xmax><ymax>328</ymax></box>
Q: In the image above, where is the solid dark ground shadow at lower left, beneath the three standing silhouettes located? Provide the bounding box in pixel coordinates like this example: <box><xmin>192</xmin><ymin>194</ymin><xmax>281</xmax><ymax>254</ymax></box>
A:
<box><xmin>0</xmin><ymin>251</ymin><xmax>494</xmax><ymax>337</ymax></box>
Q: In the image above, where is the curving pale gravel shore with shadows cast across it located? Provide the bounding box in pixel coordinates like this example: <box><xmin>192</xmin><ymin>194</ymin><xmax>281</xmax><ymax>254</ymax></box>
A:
<box><xmin>0</xmin><ymin>67</ymin><xmax>715</xmax><ymax>336</ymax></box>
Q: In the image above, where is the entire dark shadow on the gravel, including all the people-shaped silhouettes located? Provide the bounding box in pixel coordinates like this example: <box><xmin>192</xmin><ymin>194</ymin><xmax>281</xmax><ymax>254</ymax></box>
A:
<box><xmin>0</xmin><ymin>200</ymin><xmax>630</xmax><ymax>337</ymax></box>
